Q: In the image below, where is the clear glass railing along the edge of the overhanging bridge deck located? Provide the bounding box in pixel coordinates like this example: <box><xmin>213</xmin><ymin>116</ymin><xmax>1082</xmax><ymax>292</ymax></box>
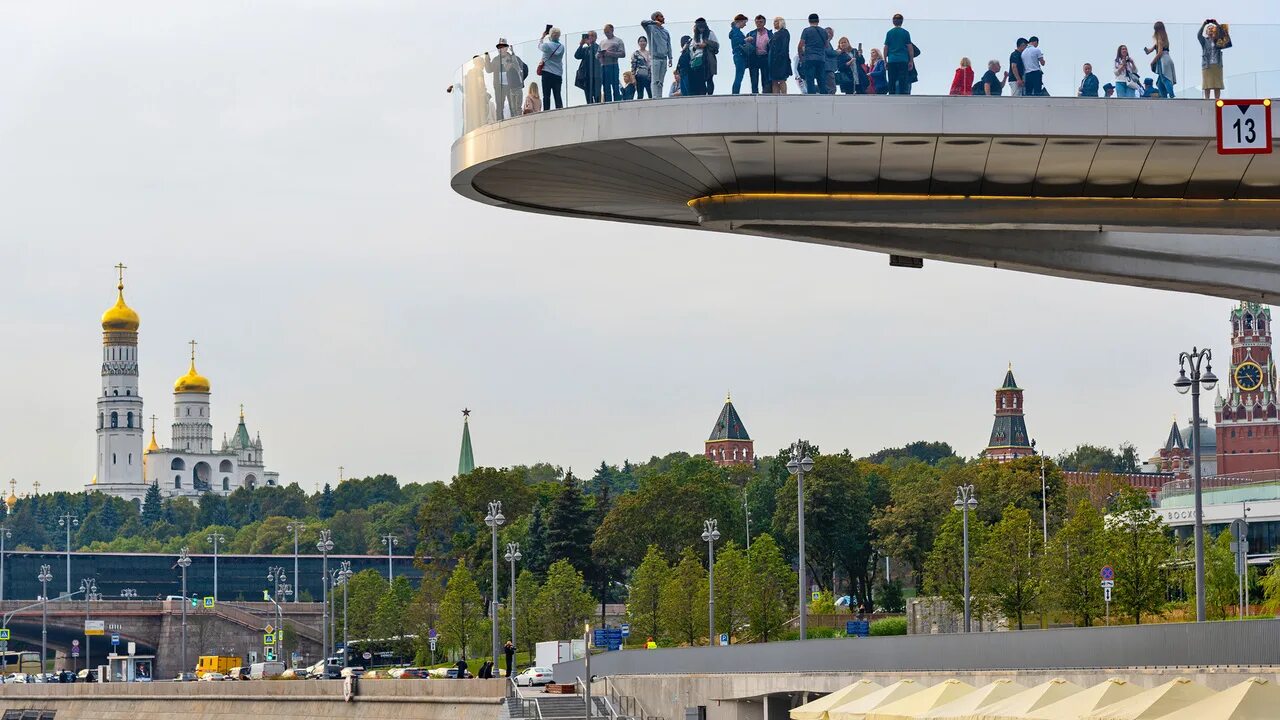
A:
<box><xmin>449</xmin><ymin>17</ymin><xmax>1280</xmax><ymax>136</ymax></box>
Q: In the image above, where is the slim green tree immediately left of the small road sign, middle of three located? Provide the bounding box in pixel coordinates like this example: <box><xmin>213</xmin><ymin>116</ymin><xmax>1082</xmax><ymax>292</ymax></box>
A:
<box><xmin>1043</xmin><ymin>500</ymin><xmax>1105</xmax><ymax>626</ymax></box>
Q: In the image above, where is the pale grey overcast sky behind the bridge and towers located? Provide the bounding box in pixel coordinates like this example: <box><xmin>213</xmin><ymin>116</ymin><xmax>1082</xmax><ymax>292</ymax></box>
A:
<box><xmin>0</xmin><ymin>0</ymin><xmax>1272</xmax><ymax>492</ymax></box>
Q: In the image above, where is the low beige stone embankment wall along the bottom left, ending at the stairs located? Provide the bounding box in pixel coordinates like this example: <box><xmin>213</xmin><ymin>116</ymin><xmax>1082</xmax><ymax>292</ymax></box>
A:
<box><xmin>0</xmin><ymin>680</ymin><xmax>506</xmax><ymax>720</ymax></box>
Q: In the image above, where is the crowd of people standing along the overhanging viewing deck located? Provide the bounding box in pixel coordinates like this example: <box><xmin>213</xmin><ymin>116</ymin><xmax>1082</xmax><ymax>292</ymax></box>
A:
<box><xmin>451</xmin><ymin>12</ymin><xmax>1231</xmax><ymax>120</ymax></box>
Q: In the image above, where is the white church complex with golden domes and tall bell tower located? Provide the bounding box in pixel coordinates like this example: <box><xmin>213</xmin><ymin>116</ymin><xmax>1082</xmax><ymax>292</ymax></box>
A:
<box><xmin>84</xmin><ymin>265</ymin><xmax>279</xmax><ymax>502</ymax></box>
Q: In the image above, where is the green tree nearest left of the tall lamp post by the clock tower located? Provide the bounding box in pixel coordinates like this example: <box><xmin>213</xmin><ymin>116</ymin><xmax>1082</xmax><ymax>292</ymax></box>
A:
<box><xmin>1105</xmin><ymin>488</ymin><xmax>1170</xmax><ymax>624</ymax></box>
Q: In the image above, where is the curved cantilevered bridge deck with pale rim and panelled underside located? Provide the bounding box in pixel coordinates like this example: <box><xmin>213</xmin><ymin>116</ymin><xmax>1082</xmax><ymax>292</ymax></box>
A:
<box><xmin>452</xmin><ymin>96</ymin><xmax>1280</xmax><ymax>301</ymax></box>
